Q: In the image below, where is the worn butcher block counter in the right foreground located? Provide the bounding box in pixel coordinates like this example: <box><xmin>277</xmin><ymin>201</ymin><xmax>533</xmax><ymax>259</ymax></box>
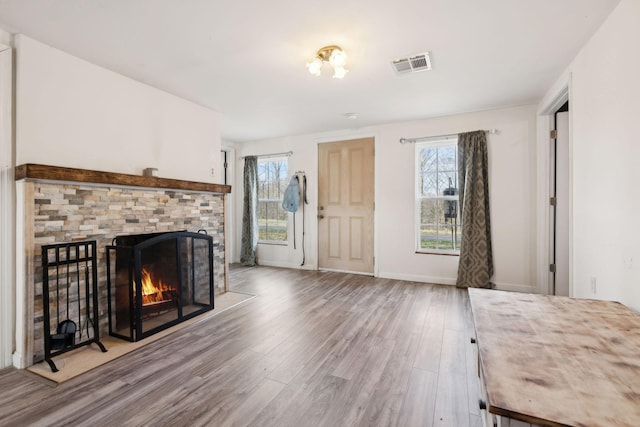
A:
<box><xmin>469</xmin><ymin>289</ymin><xmax>640</xmax><ymax>427</ymax></box>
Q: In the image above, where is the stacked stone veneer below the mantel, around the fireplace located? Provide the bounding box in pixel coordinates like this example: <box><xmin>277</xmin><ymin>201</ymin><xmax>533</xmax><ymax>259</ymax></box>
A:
<box><xmin>25</xmin><ymin>182</ymin><xmax>225</xmax><ymax>362</ymax></box>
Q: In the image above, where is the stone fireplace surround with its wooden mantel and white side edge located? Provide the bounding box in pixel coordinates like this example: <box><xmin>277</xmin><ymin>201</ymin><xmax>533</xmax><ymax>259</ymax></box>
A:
<box><xmin>15</xmin><ymin>164</ymin><xmax>231</xmax><ymax>367</ymax></box>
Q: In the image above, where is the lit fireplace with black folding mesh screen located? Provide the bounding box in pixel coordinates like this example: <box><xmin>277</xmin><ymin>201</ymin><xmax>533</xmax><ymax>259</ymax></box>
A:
<box><xmin>107</xmin><ymin>231</ymin><xmax>214</xmax><ymax>341</ymax></box>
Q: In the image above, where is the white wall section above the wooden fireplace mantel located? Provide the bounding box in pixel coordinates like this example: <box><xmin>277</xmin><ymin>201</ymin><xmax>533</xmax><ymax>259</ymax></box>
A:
<box><xmin>16</xmin><ymin>35</ymin><xmax>220</xmax><ymax>182</ymax></box>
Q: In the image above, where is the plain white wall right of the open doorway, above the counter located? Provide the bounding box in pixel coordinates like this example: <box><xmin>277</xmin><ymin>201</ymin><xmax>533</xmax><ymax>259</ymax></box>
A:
<box><xmin>544</xmin><ymin>0</ymin><xmax>640</xmax><ymax>310</ymax></box>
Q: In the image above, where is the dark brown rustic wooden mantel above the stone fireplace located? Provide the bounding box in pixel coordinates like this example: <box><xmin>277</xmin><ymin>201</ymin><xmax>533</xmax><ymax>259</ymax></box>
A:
<box><xmin>15</xmin><ymin>163</ymin><xmax>231</xmax><ymax>193</ymax></box>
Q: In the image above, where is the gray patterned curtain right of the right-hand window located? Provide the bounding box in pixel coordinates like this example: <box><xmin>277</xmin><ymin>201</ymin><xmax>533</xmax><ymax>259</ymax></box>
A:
<box><xmin>456</xmin><ymin>131</ymin><xmax>493</xmax><ymax>288</ymax></box>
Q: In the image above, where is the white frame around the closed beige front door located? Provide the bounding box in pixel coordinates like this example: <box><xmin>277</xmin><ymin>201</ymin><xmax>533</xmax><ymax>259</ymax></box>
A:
<box><xmin>310</xmin><ymin>132</ymin><xmax>380</xmax><ymax>277</ymax></box>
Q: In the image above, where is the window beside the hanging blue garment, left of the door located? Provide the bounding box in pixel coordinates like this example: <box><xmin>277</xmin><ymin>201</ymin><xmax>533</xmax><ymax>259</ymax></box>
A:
<box><xmin>258</xmin><ymin>157</ymin><xmax>288</xmax><ymax>242</ymax></box>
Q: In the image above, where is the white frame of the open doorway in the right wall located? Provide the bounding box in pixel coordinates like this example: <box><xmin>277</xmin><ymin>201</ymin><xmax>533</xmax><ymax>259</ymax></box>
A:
<box><xmin>536</xmin><ymin>74</ymin><xmax>573</xmax><ymax>296</ymax></box>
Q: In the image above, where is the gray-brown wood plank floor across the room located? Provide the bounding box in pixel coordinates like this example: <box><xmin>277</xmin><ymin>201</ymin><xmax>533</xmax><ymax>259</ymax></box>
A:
<box><xmin>0</xmin><ymin>267</ymin><xmax>482</xmax><ymax>427</ymax></box>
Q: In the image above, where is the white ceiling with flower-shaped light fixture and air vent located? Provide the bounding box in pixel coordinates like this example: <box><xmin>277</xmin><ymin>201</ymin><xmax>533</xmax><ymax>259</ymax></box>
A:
<box><xmin>0</xmin><ymin>0</ymin><xmax>620</xmax><ymax>142</ymax></box>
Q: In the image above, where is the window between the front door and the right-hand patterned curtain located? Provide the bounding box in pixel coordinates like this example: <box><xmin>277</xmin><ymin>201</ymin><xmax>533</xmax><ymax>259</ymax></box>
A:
<box><xmin>415</xmin><ymin>136</ymin><xmax>462</xmax><ymax>254</ymax></box>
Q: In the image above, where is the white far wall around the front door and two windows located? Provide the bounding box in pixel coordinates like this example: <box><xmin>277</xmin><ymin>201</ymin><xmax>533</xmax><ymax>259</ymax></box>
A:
<box><xmin>234</xmin><ymin>106</ymin><xmax>536</xmax><ymax>291</ymax></box>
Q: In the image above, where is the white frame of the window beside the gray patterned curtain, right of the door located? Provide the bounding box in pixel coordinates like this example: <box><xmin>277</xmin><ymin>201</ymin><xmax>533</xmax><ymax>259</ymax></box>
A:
<box><xmin>414</xmin><ymin>139</ymin><xmax>462</xmax><ymax>256</ymax></box>
